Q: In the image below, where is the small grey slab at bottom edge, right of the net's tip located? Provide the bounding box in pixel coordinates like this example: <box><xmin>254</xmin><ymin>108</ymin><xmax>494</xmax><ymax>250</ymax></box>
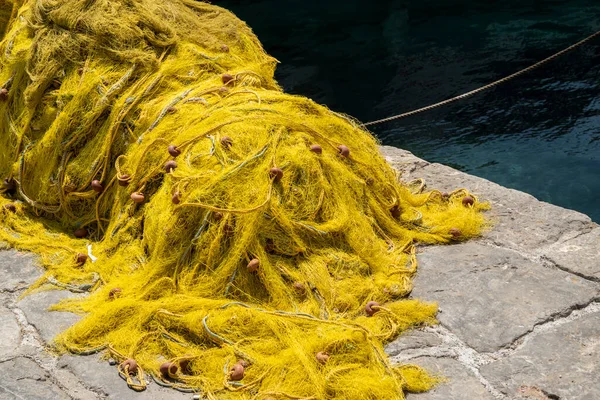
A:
<box><xmin>406</xmin><ymin>357</ymin><xmax>495</xmax><ymax>400</ymax></box>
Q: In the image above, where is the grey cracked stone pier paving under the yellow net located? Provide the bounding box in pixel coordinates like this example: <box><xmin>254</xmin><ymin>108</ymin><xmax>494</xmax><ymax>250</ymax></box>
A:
<box><xmin>0</xmin><ymin>147</ymin><xmax>600</xmax><ymax>400</ymax></box>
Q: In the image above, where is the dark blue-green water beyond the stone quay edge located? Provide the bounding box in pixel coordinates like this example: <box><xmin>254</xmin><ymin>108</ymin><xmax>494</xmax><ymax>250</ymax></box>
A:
<box><xmin>218</xmin><ymin>0</ymin><xmax>600</xmax><ymax>221</ymax></box>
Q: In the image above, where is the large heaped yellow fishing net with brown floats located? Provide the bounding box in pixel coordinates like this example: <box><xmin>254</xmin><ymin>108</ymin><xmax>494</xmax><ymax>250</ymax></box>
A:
<box><xmin>0</xmin><ymin>0</ymin><xmax>487</xmax><ymax>399</ymax></box>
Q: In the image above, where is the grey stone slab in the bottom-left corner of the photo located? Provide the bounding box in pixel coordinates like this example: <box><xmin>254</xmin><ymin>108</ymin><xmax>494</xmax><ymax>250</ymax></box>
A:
<box><xmin>0</xmin><ymin>357</ymin><xmax>71</xmax><ymax>400</ymax></box>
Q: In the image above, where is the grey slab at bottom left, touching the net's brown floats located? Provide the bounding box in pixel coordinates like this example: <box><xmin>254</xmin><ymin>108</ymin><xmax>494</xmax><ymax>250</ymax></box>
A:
<box><xmin>58</xmin><ymin>355</ymin><xmax>192</xmax><ymax>400</ymax></box>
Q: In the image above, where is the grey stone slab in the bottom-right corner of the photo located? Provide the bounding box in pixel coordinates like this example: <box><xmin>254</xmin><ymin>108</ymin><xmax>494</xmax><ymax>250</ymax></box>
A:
<box><xmin>481</xmin><ymin>312</ymin><xmax>600</xmax><ymax>400</ymax></box>
